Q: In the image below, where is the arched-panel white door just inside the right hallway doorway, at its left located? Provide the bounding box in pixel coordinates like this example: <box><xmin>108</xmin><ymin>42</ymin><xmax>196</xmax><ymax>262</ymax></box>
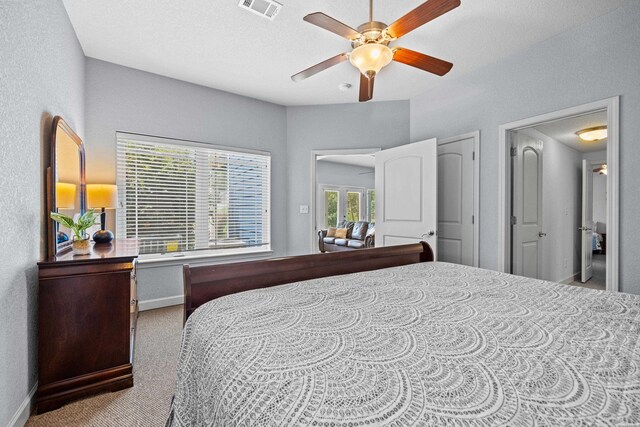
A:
<box><xmin>512</xmin><ymin>132</ymin><xmax>544</xmax><ymax>279</ymax></box>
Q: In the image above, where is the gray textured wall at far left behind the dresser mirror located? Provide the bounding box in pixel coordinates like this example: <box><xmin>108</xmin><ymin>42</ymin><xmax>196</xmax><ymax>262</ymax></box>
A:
<box><xmin>0</xmin><ymin>0</ymin><xmax>84</xmax><ymax>426</ymax></box>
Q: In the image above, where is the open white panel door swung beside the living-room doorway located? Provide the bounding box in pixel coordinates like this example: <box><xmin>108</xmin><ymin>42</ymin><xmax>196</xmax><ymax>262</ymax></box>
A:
<box><xmin>375</xmin><ymin>138</ymin><xmax>438</xmax><ymax>259</ymax></box>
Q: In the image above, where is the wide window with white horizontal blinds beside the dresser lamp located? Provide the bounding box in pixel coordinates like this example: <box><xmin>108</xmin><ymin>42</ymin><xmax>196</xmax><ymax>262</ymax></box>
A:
<box><xmin>116</xmin><ymin>132</ymin><xmax>271</xmax><ymax>254</ymax></box>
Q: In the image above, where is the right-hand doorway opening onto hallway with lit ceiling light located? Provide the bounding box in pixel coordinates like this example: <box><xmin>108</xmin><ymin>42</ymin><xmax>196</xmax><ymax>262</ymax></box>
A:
<box><xmin>499</xmin><ymin>98</ymin><xmax>618</xmax><ymax>291</ymax></box>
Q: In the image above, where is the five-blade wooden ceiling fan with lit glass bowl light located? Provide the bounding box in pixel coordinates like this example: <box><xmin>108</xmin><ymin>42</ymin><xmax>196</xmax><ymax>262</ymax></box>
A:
<box><xmin>291</xmin><ymin>0</ymin><xmax>460</xmax><ymax>102</ymax></box>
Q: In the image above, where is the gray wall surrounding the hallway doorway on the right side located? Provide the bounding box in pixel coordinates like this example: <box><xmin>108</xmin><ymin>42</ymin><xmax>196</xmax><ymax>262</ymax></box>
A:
<box><xmin>411</xmin><ymin>1</ymin><xmax>640</xmax><ymax>294</ymax></box>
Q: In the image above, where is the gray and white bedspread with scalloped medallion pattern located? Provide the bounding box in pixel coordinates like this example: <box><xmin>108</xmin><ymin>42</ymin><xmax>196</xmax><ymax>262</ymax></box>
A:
<box><xmin>168</xmin><ymin>262</ymin><xmax>640</xmax><ymax>427</ymax></box>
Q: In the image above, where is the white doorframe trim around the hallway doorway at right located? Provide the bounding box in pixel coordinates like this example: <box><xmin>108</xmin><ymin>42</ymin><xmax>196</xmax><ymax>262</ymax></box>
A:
<box><xmin>498</xmin><ymin>96</ymin><xmax>620</xmax><ymax>292</ymax></box>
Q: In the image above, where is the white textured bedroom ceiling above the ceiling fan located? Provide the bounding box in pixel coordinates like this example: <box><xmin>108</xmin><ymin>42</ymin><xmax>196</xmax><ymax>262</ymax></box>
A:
<box><xmin>63</xmin><ymin>0</ymin><xmax>623</xmax><ymax>105</ymax></box>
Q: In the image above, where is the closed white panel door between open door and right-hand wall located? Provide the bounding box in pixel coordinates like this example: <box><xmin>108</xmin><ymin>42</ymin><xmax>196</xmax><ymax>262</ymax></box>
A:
<box><xmin>438</xmin><ymin>138</ymin><xmax>474</xmax><ymax>265</ymax></box>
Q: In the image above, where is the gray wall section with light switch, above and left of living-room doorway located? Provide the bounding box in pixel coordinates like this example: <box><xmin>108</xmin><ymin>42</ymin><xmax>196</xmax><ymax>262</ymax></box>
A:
<box><xmin>287</xmin><ymin>101</ymin><xmax>409</xmax><ymax>255</ymax></box>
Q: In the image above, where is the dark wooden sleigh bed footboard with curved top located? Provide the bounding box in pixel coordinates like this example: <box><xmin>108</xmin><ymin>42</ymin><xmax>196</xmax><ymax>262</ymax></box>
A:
<box><xmin>183</xmin><ymin>242</ymin><xmax>433</xmax><ymax>322</ymax></box>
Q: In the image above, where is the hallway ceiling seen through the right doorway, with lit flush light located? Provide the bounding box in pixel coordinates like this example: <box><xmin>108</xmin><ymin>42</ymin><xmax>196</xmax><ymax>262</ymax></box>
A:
<box><xmin>535</xmin><ymin>111</ymin><xmax>607</xmax><ymax>153</ymax></box>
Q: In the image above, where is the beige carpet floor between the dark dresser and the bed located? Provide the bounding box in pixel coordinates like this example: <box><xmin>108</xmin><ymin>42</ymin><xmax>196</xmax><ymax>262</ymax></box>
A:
<box><xmin>26</xmin><ymin>305</ymin><xmax>182</xmax><ymax>427</ymax></box>
